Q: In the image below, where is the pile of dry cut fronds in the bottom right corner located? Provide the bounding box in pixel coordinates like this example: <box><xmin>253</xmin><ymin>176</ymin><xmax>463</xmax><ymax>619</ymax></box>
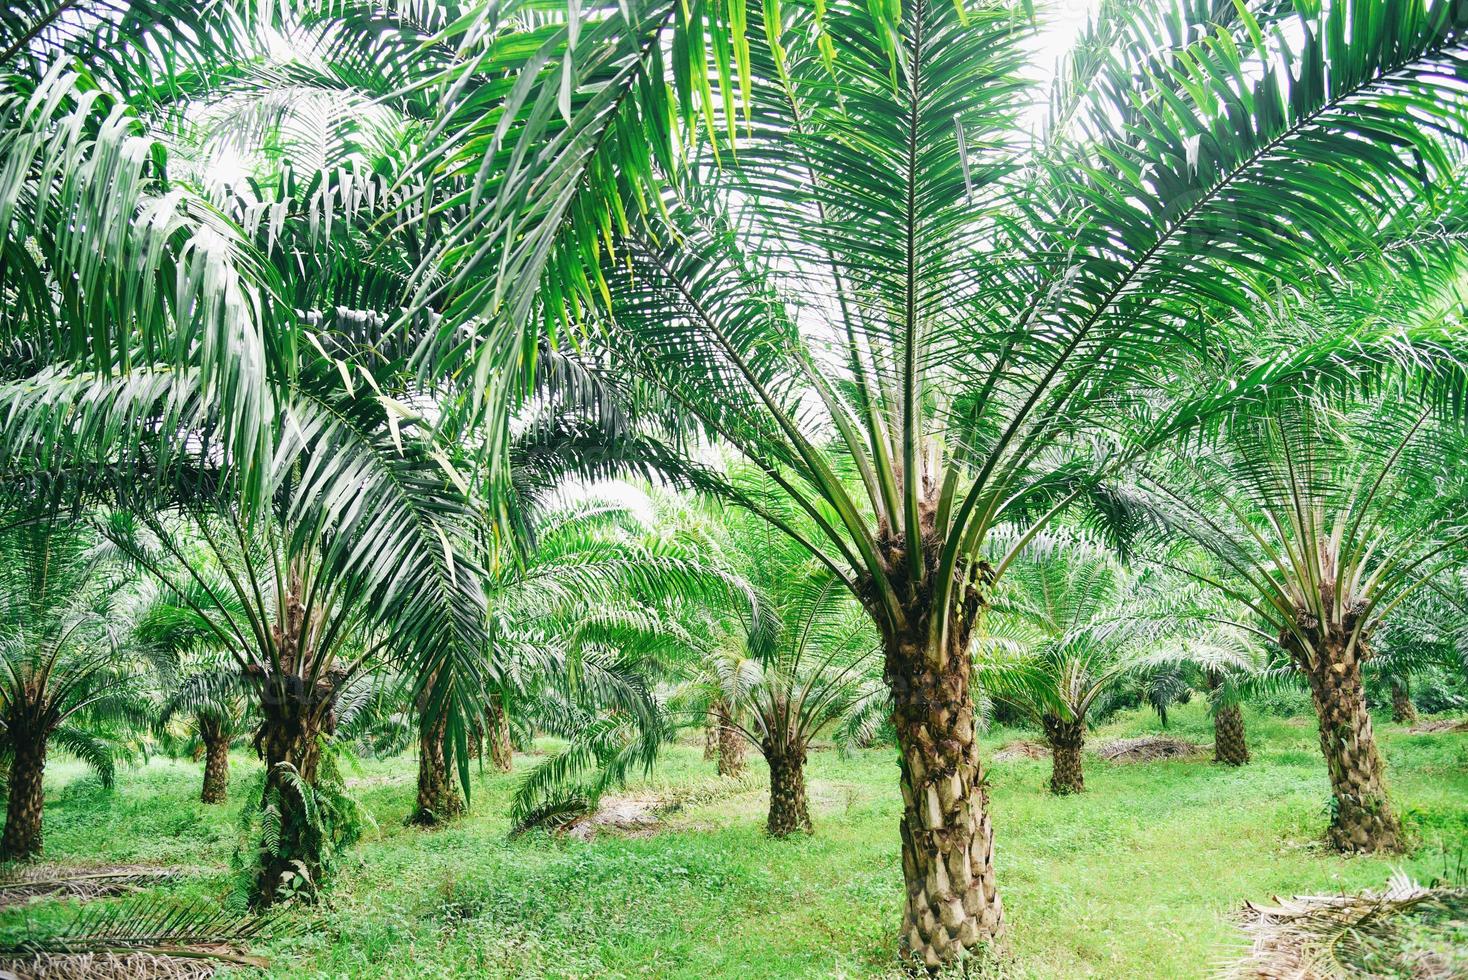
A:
<box><xmin>1226</xmin><ymin>874</ymin><xmax>1468</xmax><ymax>980</ymax></box>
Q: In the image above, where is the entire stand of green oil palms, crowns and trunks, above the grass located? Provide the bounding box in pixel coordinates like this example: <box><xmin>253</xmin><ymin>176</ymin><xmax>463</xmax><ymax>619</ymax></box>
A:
<box><xmin>0</xmin><ymin>0</ymin><xmax>1468</xmax><ymax>970</ymax></box>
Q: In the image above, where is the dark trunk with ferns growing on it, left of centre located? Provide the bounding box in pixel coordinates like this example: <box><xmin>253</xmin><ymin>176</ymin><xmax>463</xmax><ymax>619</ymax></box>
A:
<box><xmin>250</xmin><ymin>675</ymin><xmax>339</xmax><ymax>907</ymax></box>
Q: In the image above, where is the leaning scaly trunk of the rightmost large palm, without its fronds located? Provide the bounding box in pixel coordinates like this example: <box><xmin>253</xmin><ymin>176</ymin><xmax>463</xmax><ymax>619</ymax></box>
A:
<box><xmin>1307</xmin><ymin>637</ymin><xmax>1402</xmax><ymax>852</ymax></box>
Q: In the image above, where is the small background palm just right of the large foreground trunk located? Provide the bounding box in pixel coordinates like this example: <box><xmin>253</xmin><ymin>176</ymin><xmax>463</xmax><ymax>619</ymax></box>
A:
<box><xmin>976</xmin><ymin>535</ymin><xmax>1161</xmax><ymax>795</ymax></box>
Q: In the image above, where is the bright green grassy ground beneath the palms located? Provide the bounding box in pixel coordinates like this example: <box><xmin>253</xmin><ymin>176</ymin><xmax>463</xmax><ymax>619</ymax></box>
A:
<box><xmin>0</xmin><ymin>704</ymin><xmax>1468</xmax><ymax>979</ymax></box>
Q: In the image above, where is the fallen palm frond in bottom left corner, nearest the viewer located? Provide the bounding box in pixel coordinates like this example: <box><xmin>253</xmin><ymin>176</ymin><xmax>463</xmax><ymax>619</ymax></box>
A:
<box><xmin>0</xmin><ymin>898</ymin><xmax>288</xmax><ymax>976</ymax></box>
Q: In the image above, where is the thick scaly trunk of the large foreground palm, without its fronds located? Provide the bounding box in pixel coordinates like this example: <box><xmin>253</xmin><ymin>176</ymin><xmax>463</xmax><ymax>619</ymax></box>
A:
<box><xmin>884</xmin><ymin>616</ymin><xmax>1004</xmax><ymax>968</ymax></box>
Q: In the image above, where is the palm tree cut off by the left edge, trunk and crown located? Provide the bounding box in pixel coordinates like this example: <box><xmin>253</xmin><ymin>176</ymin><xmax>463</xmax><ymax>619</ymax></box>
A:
<box><xmin>0</xmin><ymin>512</ymin><xmax>148</xmax><ymax>860</ymax></box>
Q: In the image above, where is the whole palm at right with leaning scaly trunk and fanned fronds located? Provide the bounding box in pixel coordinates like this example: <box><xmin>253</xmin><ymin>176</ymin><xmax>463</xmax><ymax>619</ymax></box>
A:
<box><xmin>1158</xmin><ymin>390</ymin><xmax>1465</xmax><ymax>851</ymax></box>
